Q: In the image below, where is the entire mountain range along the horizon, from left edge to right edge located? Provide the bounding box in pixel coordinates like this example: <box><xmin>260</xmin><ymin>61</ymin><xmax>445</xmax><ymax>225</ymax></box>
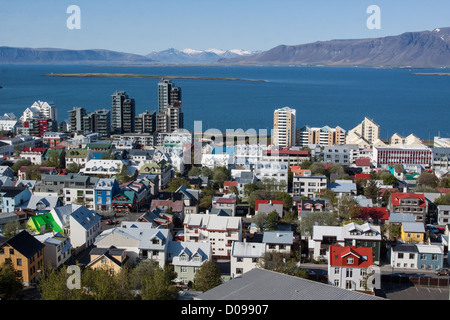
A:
<box><xmin>0</xmin><ymin>28</ymin><xmax>450</xmax><ymax>68</ymax></box>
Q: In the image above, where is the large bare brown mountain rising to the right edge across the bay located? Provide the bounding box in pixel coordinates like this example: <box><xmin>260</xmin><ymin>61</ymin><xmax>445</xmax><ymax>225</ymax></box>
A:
<box><xmin>218</xmin><ymin>28</ymin><xmax>450</xmax><ymax>68</ymax></box>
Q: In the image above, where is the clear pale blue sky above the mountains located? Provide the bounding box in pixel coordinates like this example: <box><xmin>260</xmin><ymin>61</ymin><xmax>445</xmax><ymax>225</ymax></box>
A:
<box><xmin>0</xmin><ymin>0</ymin><xmax>450</xmax><ymax>54</ymax></box>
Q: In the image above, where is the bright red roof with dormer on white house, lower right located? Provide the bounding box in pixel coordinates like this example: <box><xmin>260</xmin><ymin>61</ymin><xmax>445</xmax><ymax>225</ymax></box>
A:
<box><xmin>329</xmin><ymin>246</ymin><xmax>373</xmax><ymax>268</ymax></box>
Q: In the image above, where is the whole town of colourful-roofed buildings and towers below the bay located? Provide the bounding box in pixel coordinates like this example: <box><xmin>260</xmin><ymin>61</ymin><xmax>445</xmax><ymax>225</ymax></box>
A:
<box><xmin>0</xmin><ymin>79</ymin><xmax>450</xmax><ymax>300</ymax></box>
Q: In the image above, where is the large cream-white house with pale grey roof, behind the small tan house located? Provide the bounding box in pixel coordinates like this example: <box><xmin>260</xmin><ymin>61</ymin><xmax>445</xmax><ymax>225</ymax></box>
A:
<box><xmin>95</xmin><ymin>227</ymin><xmax>172</xmax><ymax>268</ymax></box>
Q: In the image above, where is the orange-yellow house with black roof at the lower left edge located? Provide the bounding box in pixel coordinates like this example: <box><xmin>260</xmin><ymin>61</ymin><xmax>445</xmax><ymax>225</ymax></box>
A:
<box><xmin>0</xmin><ymin>230</ymin><xmax>45</xmax><ymax>286</ymax></box>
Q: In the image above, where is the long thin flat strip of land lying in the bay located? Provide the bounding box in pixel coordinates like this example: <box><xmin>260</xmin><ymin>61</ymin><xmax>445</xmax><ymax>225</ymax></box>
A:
<box><xmin>43</xmin><ymin>73</ymin><xmax>267</xmax><ymax>82</ymax></box>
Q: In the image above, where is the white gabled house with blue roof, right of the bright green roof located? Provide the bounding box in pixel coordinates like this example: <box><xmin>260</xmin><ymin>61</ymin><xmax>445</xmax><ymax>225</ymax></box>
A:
<box><xmin>69</xmin><ymin>206</ymin><xmax>101</xmax><ymax>251</ymax></box>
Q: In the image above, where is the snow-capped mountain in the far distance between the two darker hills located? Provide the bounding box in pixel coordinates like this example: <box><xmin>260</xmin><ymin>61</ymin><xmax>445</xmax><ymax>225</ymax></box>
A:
<box><xmin>146</xmin><ymin>48</ymin><xmax>259</xmax><ymax>64</ymax></box>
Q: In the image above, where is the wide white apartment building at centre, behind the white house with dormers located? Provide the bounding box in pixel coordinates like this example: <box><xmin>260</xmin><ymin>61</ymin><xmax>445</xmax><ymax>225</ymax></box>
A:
<box><xmin>183</xmin><ymin>214</ymin><xmax>242</xmax><ymax>259</ymax></box>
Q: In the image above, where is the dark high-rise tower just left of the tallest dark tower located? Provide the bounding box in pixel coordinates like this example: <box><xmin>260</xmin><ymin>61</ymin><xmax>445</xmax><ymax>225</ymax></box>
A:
<box><xmin>111</xmin><ymin>91</ymin><xmax>136</xmax><ymax>133</ymax></box>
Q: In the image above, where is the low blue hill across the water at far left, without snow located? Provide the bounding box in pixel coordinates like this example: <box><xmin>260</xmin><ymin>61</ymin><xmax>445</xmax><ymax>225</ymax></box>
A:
<box><xmin>0</xmin><ymin>47</ymin><xmax>152</xmax><ymax>64</ymax></box>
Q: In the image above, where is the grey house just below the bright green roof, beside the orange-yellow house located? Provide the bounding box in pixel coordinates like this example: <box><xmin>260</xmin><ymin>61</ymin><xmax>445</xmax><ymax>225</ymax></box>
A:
<box><xmin>34</xmin><ymin>232</ymin><xmax>72</xmax><ymax>269</ymax></box>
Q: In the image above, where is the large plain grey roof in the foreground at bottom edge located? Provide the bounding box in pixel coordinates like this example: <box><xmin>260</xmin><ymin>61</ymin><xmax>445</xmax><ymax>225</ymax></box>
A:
<box><xmin>195</xmin><ymin>268</ymin><xmax>384</xmax><ymax>300</ymax></box>
